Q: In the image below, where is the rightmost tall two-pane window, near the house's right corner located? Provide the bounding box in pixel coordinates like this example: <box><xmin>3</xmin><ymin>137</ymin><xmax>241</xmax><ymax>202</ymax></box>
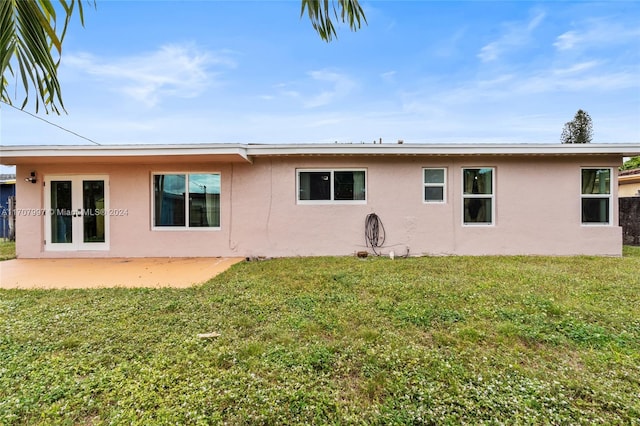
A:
<box><xmin>582</xmin><ymin>169</ymin><xmax>612</xmax><ymax>225</ymax></box>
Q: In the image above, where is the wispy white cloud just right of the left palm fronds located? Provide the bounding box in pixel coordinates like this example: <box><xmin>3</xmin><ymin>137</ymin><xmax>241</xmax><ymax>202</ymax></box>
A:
<box><xmin>64</xmin><ymin>44</ymin><xmax>236</xmax><ymax>107</ymax></box>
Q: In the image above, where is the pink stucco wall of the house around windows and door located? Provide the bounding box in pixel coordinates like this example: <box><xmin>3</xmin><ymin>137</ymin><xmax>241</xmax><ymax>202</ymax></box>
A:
<box><xmin>16</xmin><ymin>156</ymin><xmax>622</xmax><ymax>258</ymax></box>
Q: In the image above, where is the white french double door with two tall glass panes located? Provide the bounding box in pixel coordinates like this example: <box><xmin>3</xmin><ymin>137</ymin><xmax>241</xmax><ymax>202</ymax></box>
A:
<box><xmin>44</xmin><ymin>175</ymin><xmax>109</xmax><ymax>251</ymax></box>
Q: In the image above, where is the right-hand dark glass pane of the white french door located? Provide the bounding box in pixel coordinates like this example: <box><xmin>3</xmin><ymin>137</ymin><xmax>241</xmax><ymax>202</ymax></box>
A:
<box><xmin>82</xmin><ymin>180</ymin><xmax>105</xmax><ymax>243</ymax></box>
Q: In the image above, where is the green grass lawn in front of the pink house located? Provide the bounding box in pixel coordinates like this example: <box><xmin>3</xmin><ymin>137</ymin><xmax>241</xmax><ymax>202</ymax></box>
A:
<box><xmin>0</xmin><ymin>247</ymin><xmax>640</xmax><ymax>425</ymax></box>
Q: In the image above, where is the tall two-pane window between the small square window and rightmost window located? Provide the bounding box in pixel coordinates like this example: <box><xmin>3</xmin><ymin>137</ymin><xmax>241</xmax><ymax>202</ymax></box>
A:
<box><xmin>462</xmin><ymin>167</ymin><xmax>494</xmax><ymax>225</ymax></box>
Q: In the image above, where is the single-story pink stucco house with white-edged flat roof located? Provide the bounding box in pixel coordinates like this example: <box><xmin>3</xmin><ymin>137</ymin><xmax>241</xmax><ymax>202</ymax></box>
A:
<box><xmin>0</xmin><ymin>144</ymin><xmax>640</xmax><ymax>258</ymax></box>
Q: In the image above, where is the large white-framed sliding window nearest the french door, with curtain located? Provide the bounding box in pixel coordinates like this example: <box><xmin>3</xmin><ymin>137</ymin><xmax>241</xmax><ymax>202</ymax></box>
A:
<box><xmin>153</xmin><ymin>173</ymin><xmax>220</xmax><ymax>228</ymax></box>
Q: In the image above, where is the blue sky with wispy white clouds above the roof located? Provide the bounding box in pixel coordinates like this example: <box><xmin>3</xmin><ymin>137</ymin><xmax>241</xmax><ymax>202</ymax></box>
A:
<box><xmin>0</xmin><ymin>0</ymin><xmax>640</xmax><ymax>145</ymax></box>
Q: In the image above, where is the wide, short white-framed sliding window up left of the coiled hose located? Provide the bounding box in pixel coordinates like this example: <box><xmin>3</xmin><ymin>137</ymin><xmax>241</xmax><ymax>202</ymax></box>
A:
<box><xmin>298</xmin><ymin>170</ymin><xmax>367</xmax><ymax>204</ymax></box>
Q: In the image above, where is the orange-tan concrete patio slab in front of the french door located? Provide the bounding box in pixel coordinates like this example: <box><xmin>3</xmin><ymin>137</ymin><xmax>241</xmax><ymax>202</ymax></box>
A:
<box><xmin>0</xmin><ymin>258</ymin><xmax>244</xmax><ymax>289</ymax></box>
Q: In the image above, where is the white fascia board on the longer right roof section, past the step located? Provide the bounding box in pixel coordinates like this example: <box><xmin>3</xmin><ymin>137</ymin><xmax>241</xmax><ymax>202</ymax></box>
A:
<box><xmin>247</xmin><ymin>143</ymin><xmax>640</xmax><ymax>157</ymax></box>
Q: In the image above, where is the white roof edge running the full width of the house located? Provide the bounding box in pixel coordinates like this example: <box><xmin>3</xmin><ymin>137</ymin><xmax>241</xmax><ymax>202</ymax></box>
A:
<box><xmin>0</xmin><ymin>143</ymin><xmax>640</xmax><ymax>165</ymax></box>
